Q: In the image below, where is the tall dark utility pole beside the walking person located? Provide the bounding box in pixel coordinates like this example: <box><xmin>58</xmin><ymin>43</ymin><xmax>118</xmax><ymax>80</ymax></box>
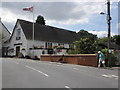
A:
<box><xmin>107</xmin><ymin>0</ymin><xmax>111</xmax><ymax>50</ymax></box>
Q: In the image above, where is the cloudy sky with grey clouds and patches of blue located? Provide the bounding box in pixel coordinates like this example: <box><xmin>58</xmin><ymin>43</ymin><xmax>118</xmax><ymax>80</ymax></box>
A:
<box><xmin>0</xmin><ymin>0</ymin><xmax>120</xmax><ymax>37</ymax></box>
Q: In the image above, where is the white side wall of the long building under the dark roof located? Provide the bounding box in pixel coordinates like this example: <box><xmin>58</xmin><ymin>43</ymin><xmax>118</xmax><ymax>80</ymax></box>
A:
<box><xmin>26</xmin><ymin>40</ymin><xmax>69</xmax><ymax>57</ymax></box>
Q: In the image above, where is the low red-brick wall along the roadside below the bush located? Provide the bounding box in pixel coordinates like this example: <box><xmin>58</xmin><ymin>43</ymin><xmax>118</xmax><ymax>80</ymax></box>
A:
<box><xmin>40</xmin><ymin>54</ymin><xmax>98</xmax><ymax>67</ymax></box>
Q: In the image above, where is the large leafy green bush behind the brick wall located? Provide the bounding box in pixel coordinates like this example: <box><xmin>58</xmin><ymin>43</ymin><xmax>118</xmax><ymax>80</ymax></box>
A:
<box><xmin>69</xmin><ymin>30</ymin><xmax>98</xmax><ymax>54</ymax></box>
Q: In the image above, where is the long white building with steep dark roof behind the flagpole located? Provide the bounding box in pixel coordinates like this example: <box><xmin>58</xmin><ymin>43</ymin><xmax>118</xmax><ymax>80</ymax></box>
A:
<box><xmin>8</xmin><ymin>19</ymin><xmax>78</xmax><ymax>57</ymax></box>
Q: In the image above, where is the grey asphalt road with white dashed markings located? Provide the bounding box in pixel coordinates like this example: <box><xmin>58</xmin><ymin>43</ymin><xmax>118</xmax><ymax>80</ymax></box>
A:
<box><xmin>2</xmin><ymin>58</ymin><xmax>118</xmax><ymax>90</ymax></box>
